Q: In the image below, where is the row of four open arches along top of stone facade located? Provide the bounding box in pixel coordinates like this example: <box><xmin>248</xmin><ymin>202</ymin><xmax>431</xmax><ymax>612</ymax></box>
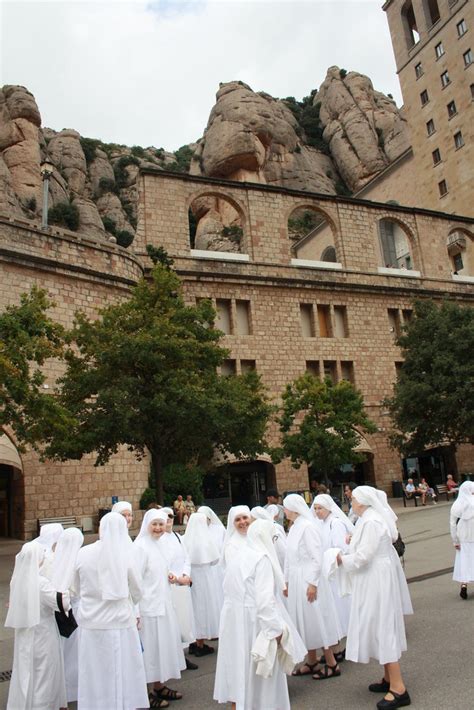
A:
<box><xmin>188</xmin><ymin>192</ymin><xmax>474</xmax><ymax>275</ymax></box>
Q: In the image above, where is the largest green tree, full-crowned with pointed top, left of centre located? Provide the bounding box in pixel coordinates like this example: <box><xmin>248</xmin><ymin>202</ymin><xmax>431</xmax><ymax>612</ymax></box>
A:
<box><xmin>48</xmin><ymin>262</ymin><xmax>271</xmax><ymax>501</ymax></box>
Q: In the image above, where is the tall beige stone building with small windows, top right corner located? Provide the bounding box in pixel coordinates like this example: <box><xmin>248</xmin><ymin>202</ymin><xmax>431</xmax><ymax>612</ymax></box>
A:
<box><xmin>384</xmin><ymin>0</ymin><xmax>474</xmax><ymax>217</ymax></box>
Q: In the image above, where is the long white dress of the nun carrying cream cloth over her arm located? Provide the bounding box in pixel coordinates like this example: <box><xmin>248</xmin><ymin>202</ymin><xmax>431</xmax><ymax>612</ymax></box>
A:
<box><xmin>214</xmin><ymin>548</ymin><xmax>290</xmax><ymax>710</ymax></box>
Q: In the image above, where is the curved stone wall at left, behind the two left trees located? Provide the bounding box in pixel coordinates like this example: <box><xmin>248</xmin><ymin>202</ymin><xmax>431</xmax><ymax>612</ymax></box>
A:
<box><xmin>0</xmin><ymin>219</ymin><xmax>148</xmax><ymax>538</ymax></box>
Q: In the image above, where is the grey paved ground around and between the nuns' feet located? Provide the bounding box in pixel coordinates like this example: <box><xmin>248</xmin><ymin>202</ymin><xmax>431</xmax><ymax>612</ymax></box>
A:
<box><xmin>0</xmin><ymin>500</ymin><xmax>474</xmax><ymax>710</ymax></box>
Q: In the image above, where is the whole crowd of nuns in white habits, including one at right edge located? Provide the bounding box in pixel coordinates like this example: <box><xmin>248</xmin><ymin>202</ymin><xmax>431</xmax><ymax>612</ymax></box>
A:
<box><xmin>6</xmin><ymin>482</ymin><xmax>474</xmax><ymax>710</ymax></box>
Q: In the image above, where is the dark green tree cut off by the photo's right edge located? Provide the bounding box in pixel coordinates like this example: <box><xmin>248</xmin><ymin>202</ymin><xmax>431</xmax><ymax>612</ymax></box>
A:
<box><xmin>385</xmin><ymin>301</ymin><xmax>474</xmax><ymax>454</ymax></box>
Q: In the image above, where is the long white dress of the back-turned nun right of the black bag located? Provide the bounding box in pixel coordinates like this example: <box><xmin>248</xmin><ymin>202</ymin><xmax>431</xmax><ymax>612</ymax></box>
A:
<box><xmin>73</xmin><ymin>544</ymin><xmax>149</xmax><ymax>710</ymax></box>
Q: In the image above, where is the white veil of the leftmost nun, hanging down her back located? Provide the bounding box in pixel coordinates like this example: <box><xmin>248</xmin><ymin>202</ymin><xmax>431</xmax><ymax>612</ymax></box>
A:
<box><xmin>5</xmin><ymin>540</ymin><xmax>44</xmax><ymax>629</ymax></box>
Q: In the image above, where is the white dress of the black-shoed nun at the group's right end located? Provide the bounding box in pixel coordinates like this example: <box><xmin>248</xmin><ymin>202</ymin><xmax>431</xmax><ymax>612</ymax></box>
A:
<box><xmin>342</xmin><ymin>508</ymin><xmax>407</xmax><ymax>664</ymax></box>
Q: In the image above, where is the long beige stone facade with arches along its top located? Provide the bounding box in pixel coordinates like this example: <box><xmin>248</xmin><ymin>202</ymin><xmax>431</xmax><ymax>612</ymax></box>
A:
<box><xmin>135</xmin><ymin>171</ymin><xmax>474</xmax><ymax>500</ymax></box>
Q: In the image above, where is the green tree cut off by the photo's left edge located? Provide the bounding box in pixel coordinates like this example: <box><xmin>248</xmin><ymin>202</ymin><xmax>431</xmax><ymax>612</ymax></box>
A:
<box><xmin>0</xmin><ymin>287</ymin><xmax>71</xmax><ymax>449</ymax></box>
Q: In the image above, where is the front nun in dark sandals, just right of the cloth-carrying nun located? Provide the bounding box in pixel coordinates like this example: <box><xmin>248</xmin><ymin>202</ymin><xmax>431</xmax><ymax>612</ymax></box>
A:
<box><xmin>283</xmin><ymin>493</ymin><xmax>342</xmax><ymax>680</ymax></box>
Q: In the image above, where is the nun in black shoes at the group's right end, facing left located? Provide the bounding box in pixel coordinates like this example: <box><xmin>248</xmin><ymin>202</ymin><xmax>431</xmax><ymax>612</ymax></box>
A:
<box><xmin>337</xmin><ymin>486</ymin><xmax>411</xmax><ymax>710</ymax></box>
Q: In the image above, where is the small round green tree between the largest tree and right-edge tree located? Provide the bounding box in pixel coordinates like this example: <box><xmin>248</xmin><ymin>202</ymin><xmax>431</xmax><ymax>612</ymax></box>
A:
<box><xmin>274</xmin><ymin>373</ymin><xmax>376</xmax><ymax>482</ymax></box>
